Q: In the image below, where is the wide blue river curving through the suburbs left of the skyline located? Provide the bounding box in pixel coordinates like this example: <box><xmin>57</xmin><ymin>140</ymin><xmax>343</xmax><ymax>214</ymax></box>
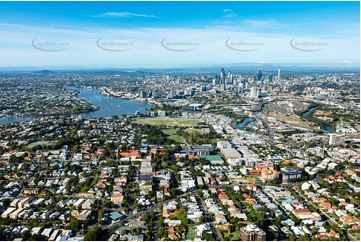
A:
<box><xmin>0</xmin><ymin>87</ymin><xmax>152</xmax><ymax>124</ymax></box>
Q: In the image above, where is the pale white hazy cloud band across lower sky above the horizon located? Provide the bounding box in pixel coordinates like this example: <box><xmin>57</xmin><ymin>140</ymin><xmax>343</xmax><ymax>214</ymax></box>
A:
<box><xmin>0</xmin><ymin>23</ymin><xmax>360</xmax><ymax>68</ymax></box>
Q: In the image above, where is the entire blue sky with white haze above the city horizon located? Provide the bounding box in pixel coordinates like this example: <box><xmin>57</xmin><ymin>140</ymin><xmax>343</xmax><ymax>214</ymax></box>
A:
<box><xmin>0</xmin><ymin>1</ymin><xmax>360</xmax><ymax>68</ymax></box>
